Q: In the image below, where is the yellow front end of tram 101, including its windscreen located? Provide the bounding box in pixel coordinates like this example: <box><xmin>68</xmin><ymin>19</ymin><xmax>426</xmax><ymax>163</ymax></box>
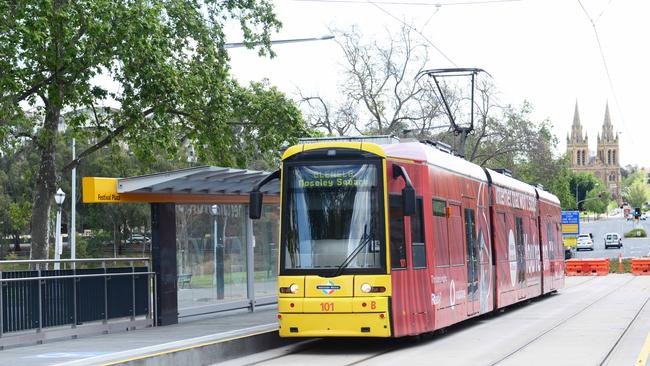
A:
<box><xmin>278</xmin><ymin>142</ymin><xmax>392</xmax><ymax>337</ymax></box>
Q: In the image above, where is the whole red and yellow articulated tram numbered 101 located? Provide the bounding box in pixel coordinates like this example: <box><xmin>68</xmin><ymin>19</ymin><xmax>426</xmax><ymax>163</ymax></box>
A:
<box><xmin>251</xmin><ymin>142</ymin><xmax>564</xmax><ymax>337</ymax></box>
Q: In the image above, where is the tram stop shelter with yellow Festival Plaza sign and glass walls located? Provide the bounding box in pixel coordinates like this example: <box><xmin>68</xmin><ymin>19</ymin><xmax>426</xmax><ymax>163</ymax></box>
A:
<box><xmin>83</xmin><ymin>166</ymin><xmax>279</xmax><ymax>325</ymax></box>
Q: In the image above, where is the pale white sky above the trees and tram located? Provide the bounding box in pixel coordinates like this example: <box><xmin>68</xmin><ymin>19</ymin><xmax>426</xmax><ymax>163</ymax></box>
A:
<box><xmin>228</xmin><ymin>0</ymin><xmax>650</xmax><ymax>167</ymax></box>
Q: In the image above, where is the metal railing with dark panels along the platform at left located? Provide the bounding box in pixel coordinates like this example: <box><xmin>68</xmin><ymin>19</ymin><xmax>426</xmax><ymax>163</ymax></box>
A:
<box><xmin>0</xmin><ymin>258</ymin><xmax>156</xmax><ymax>347</ymax></box>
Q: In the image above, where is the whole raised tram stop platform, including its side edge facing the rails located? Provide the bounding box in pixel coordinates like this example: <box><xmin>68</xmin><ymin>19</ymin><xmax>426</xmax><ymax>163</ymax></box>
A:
<box><xmin>0</xmin><ymin>306</ymin><xmax>290</xmax><ymax>366</ymax></box>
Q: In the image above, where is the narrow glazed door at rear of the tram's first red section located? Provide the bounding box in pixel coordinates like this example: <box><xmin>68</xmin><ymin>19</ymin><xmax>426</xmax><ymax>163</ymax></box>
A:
<box><xmin>463</xmin><ymin>207</ymin><xmax>480</xmax><ymax>315</ymax></box>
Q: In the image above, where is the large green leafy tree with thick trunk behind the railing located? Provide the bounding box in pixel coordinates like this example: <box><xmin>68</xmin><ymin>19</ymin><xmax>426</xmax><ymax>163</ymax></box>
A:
<box><xmin>0</xmin><ymin>0</ymin><xmax>303</xmax><ymax>259</ymax></box>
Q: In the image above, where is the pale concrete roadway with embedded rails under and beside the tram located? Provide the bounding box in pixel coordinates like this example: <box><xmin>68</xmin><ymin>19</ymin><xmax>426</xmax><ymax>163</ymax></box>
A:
<box><xmin>218</xmin><ymin>274</ymin><xmax>650</xmax><ymax>366</ymax></box>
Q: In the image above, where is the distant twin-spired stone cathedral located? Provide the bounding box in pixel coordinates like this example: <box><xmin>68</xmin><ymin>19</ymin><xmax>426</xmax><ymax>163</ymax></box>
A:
<box><xmin>567</xmin><ymin>102</ymin><xmax>621</xmax><ymax>202</ymax></box>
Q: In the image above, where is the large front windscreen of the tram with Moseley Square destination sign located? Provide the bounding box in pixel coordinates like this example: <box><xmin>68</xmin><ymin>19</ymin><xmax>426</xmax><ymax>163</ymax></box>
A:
<box><xmin>283</xmin><ymin>163</ymin><xmax>384</xmax><ymax>273</ymax></box>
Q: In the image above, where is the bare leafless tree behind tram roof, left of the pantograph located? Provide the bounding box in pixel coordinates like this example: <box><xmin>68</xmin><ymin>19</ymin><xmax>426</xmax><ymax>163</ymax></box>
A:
<box><xmin>300</xmin><ymin>26</ymin><xmax>441</xmax><ymax>136</ymax></box>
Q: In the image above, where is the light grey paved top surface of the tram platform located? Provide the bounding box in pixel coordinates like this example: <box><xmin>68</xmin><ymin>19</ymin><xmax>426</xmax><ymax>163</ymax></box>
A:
<box><xmin>0</xmin><ymin>306</ymin><xmax>277</xmax><ymax>366</ymax></box>
